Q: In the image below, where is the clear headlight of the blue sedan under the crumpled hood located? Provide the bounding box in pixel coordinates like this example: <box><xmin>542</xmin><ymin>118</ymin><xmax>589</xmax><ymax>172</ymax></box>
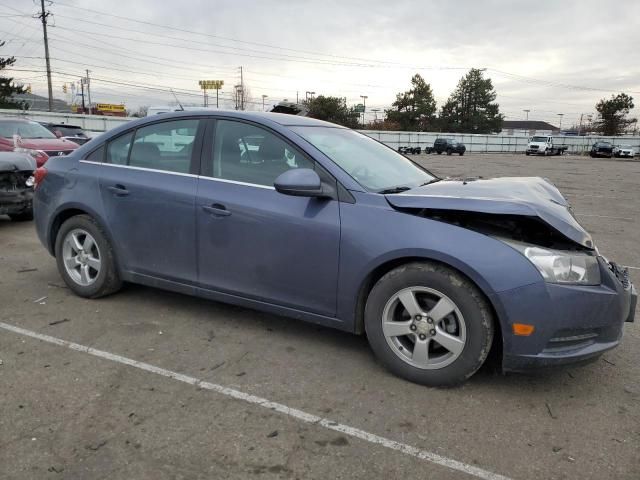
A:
<box><xmin>506</xmin><ymin>240</ymin><xmax>600</xmax><ymax>285</ymax></box>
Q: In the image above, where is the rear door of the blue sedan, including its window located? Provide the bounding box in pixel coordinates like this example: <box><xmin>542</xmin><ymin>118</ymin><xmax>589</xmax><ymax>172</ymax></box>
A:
<box><xmin>100</xmin><ymin>118</ymin><xmax>204</xmax><ymax>284</ymax></box>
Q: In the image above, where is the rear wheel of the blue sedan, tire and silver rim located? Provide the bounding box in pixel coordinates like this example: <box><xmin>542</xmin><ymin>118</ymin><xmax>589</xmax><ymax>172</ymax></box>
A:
<box><xmin>55</xmin><ymin>215</ymin><xmax>122</xmax><ymax>298</ymax></box>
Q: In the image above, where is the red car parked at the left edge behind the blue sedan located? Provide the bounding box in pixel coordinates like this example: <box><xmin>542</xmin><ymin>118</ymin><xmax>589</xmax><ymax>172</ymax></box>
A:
<box><xmin>0</xmin><ymin>118</ymin><xmax>78</xmax><ymax>167</ymax></box>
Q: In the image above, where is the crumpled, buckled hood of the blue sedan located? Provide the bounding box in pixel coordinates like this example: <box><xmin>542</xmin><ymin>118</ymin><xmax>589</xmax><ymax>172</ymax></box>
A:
<box><xmin>386</xmin><ymin>177</ymin><xmax>593</xmax><ymax>248</ymax></box>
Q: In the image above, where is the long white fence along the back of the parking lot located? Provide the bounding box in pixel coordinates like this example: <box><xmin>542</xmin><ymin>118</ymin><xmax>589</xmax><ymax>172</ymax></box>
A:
<box><xmin>0</xmin><ymin>109</ymin><xmax>640</xmax><ymax>153</ymax></box>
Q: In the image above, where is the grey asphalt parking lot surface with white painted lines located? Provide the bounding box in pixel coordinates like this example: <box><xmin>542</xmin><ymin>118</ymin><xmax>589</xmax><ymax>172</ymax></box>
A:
<box><xmin>0</xmin><ymin>154</ymin><xmax>640</xmax><ymax>479</ymax></box>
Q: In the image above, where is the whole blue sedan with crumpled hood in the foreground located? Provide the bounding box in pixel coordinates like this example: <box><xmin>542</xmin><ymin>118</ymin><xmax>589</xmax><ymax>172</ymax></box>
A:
<box><xmin>34</xmin><ymin>111</ymin><xmax>636</xmax><ymax>386</ymax></box>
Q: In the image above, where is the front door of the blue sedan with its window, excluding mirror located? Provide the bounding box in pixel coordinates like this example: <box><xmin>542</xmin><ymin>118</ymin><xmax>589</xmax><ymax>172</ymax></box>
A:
<box><xmin>196</xmin><ymin>120</ymin><xmax>340</xmax><ymax>316</ymax></box>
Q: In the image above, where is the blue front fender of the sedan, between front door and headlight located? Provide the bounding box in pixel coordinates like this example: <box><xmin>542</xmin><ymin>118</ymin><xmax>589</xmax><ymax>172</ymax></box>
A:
<box><xmin>337</xmin><ymin>194</ymin><xmax>541</xmax><ymax>328</ymax></box>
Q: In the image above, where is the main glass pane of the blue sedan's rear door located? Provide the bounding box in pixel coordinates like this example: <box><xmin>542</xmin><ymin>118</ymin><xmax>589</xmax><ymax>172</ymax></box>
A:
<box><xmin>129</xmin><ymin>119</ymin><xmax>199</xmax><ymax>173</ymax></box>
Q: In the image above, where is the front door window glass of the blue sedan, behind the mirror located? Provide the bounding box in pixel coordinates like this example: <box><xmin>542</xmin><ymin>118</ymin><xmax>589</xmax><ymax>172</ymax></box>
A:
<box><xmin>209</xmin><ymin>120</ymin><xmax>314</xmax><ymax>187</ymax></box>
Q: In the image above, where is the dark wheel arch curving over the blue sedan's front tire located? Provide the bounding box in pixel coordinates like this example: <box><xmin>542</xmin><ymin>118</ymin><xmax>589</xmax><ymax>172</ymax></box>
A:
<box><xmin>354</xmin><ymin>255</ymin><xmax>503</xmax><ymax>358</ymax></box>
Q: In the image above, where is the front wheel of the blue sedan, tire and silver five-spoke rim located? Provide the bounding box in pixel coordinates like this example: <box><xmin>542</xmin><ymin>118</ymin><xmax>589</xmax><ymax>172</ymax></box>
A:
<box><xmin>364</xmin><ymin>262</ymin><xmax>495</xmax><ymax>387</ymax></box>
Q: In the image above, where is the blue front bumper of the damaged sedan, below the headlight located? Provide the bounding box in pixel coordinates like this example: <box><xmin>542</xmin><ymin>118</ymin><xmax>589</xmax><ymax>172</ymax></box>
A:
<box><xmin>494</xmin><ymin>258</ymin><xmax>637</xmax><ymax>371</ymax></box>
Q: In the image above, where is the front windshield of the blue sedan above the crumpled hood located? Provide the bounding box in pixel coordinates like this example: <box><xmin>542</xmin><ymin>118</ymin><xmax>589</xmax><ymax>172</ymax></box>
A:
<box><xmin>291</xmin><ymin>127</ymin><xmax>435</xmax><ymax>192</ymax></box>
